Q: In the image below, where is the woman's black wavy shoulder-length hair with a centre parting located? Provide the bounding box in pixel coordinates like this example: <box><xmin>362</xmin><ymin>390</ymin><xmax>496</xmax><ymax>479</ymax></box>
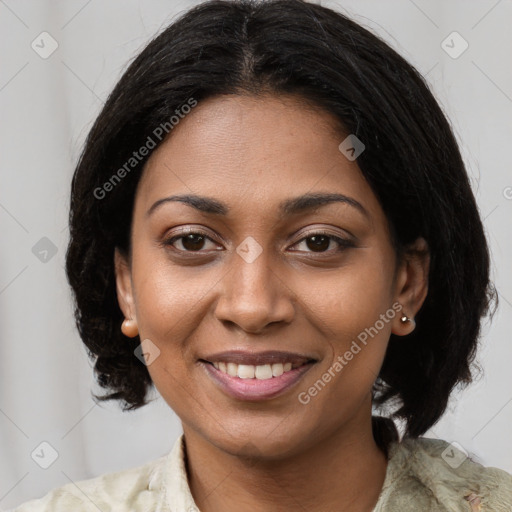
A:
<box><xmin>66</xmin><ymin>0</ymin><xmax>496</xmax><ymax>456</ymax></box>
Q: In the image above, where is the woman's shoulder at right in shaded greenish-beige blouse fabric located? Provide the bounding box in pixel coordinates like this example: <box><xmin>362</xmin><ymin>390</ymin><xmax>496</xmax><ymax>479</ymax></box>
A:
<box><xmin>376</xmin><ymin>437</ymin><xmax>512</xmax><ymax>512</ymax></box>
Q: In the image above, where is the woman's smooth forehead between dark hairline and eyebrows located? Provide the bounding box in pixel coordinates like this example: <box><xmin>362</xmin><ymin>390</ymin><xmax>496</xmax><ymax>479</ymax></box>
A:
<box><xmin>136</xmin><ymin>95</ymin><xmax>378</xmax><ymax>220</ymax></box>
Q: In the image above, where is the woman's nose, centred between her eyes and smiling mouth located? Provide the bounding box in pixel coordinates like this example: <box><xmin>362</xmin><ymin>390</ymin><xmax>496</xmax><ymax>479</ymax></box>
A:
<box><xmin>215</xmin><ymin>246</ymin><xmax>295</xmax><ymax>334</ymax></box>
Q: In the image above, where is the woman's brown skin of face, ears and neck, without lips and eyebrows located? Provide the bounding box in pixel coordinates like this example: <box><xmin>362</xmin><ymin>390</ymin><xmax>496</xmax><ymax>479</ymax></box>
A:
<box><xmin>115</xmin><ymin>95</ymin><xmax>429</xmax><ymax>512</ymax></box>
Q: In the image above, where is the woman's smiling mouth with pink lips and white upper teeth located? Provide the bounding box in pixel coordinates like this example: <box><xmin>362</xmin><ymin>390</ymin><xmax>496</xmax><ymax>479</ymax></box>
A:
<box><xmin>199</xmin><ymin>351</ymin><xmax>317</xmax><ymax>401</ymax></box>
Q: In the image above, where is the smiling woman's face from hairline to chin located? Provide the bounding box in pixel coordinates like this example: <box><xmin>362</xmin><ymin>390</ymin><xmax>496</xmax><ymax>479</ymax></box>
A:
<box><xmin>116</xmin><ymin>96</ymin><xmax>419</xmax><ymax>457</ymax></box>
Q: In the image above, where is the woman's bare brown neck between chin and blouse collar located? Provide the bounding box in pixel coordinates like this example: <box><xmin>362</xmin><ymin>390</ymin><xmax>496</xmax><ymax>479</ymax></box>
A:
<box><xmin>184</xmin><ymin>410</ymin><xmax>387</xmax><ymax>512</ymax></box>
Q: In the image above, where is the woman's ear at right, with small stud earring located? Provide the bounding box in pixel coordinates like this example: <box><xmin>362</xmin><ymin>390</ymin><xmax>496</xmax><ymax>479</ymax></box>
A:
<box><xmin>391</xmin><ymin>238</ymin><xmax>430</xmax><ymax>336</ymax></box>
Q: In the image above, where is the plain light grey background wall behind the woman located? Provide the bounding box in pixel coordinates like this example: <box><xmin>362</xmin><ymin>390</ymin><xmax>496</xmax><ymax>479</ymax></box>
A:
<box><xmin>0</xmin><ymin>0</ymin><xmax>512</xmax><ymax>509</ymax></box>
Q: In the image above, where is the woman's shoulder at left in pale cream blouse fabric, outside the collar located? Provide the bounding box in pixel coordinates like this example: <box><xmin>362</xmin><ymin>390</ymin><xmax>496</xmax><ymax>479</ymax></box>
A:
<box><xmin>13</xmin><ymin>455</ymin><xmax>169</xmax><ymax>512</ymax></box>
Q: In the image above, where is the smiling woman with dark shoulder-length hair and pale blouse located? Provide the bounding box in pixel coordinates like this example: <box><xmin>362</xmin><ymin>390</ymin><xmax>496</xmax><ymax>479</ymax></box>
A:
<box><xmin>17</xmin><ymin>0</ymin><xmax>512</xmax><ymax>512</ymax></box>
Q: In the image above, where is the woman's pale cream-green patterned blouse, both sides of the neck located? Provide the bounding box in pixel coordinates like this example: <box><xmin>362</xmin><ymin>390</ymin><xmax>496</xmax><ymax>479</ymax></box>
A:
<box><xmin>14</xmin><ymin>435</ymin><xmax>512</xmax><ymax>512</ymax></box>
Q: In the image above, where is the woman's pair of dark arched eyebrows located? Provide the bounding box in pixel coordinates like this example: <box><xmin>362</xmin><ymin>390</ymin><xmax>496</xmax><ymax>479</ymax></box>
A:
<box><xmin>146</xmin><ymin>192</ymin><xmax>370</xmax><ymax>218</ymax></box>
